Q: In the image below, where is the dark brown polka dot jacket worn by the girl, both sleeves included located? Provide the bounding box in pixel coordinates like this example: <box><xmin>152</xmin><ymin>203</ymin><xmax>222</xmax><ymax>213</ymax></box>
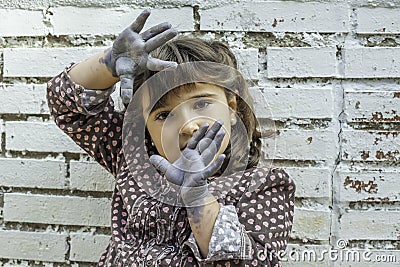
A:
<box><xmin>47</xmin><ymin>64</ymin><xmax>295</xmax><ymax>266</ymax></box>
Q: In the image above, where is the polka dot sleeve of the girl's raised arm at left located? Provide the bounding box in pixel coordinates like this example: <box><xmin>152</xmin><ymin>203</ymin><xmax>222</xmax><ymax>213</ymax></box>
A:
<box><xmin>47</xmin><ymin>64</ymin><xmax>123</xmax><ymax>176</ymax></box>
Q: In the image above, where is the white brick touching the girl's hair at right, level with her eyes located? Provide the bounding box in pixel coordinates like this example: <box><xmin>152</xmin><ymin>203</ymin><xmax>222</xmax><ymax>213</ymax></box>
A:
<box><xmin>250</xmin><ymin>88</ymin><xmax>334</xmax><ymax>120</ymax></box>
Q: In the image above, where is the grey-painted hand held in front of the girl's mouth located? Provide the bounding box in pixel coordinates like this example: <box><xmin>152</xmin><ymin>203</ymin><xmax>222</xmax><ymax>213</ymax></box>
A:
<box><xmin>150</xmin><ymin>121</ymin><xmax>225</xmax><ymax>207</ymax></box>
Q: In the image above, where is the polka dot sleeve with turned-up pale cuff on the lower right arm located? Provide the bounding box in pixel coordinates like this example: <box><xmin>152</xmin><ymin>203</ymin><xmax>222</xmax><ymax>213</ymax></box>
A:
<box><xmin>187</xmin><ymin>168</ymin><xmax>295</xmax><ymax>266</ymax></box>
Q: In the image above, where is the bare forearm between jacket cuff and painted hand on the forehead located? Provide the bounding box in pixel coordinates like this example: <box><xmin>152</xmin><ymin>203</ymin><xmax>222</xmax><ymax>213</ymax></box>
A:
<box><xmin>68</xmin><ymin>51</ymin><xmax>119</xmax><ymax>89</ymax></box>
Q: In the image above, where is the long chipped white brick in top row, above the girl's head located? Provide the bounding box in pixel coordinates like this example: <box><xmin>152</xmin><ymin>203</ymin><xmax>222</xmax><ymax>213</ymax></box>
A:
<box><xmin>199</xmin><ymin>1</ymin><xmax>349</xmax><ymax>32</ymax></box>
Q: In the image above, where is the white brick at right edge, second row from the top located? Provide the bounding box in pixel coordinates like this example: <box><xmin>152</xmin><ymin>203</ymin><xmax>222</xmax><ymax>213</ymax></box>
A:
<box><xmin>344</xmin><ymin>47</ymin><xmax>400</xmax><ymax>78</ymax></box>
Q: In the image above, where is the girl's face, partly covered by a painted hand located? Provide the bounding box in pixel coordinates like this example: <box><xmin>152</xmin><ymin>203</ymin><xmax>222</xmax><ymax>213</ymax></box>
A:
<box><xmin>143</xmin><ymin>83</ymin><xmax>236</xmax><ymax>163</ymax></box>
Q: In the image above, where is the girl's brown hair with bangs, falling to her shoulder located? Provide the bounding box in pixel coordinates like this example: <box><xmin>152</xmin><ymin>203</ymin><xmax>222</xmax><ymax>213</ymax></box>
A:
<box><xmin>134</xmin><ymin>37</ymin><xmax>261</xmax><ymax>169</ymax></box>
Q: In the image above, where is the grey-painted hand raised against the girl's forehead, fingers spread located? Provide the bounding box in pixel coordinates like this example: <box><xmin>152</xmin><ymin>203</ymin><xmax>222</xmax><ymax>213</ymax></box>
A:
<box><xmin>103</xmin><ymin>10</ymin><xmax>178</xmax><ymax>104</ymax></box>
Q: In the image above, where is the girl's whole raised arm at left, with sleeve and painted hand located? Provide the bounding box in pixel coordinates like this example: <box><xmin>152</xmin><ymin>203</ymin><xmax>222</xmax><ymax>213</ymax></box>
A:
<box><xmin>47</xmin><ymin>10</ymin><xmax>177</xmax><ymax>176</ymax></box>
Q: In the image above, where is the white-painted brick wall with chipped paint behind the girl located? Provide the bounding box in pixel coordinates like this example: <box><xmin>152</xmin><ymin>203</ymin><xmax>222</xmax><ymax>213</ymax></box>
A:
<box><xmin>0</xmin><ymin>0</ymin><xmax>400</xmax><ymax>266</ymax></box>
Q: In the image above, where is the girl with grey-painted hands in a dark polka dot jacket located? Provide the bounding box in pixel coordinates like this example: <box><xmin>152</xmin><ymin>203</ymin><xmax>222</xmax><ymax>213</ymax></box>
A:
<box><xmin>48</xmin><ymin>11</ymin><xmax>295</xmax><ymax>266</ymax></box>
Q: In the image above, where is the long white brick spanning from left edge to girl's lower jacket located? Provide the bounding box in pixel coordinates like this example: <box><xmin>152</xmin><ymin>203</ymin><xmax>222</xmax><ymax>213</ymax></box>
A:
<box><xmin>4</xmin><ymin>193</ymin><xmax>111</xmax><ymax>226</ymax></box>
